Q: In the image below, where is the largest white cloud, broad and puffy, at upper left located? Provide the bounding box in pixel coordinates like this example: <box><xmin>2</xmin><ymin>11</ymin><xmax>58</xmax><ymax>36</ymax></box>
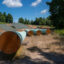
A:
<box><xmin>3</xmin><ymin>0</ymin><xmax>23</xmax><ymax>7</ymax></box>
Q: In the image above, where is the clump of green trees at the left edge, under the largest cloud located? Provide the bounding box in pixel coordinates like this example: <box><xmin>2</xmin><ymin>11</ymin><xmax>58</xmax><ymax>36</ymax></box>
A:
<box><xmin>0</xmin><ymin>12</ymin><xmax>13</xmax><ymax>23</ymax></box>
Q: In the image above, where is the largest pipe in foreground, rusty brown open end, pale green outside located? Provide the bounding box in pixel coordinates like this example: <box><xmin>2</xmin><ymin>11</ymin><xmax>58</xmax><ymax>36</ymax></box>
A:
<box><xmin>0</xmin><ymin>31</ymin><xmax>26</xmax><ymax>59</ymax></box>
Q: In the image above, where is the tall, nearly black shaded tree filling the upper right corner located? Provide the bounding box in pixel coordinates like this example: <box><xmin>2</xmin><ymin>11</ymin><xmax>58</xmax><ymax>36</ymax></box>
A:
<box><xmin>47</xmin><ymin>0</ymin><xmax>64</xmax><ymax>29</ymax></box>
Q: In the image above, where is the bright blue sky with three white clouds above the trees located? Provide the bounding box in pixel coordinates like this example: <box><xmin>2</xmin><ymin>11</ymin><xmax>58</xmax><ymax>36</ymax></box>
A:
<box><xmin>0</xmin><ymin>0</ymin><xmax>51</xmax><ymax>22</ymax></box>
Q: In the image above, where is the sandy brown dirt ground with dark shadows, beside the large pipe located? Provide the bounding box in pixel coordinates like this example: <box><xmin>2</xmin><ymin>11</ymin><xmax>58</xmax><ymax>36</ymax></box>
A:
<box><xmin>0</xmin><ymin>34</ymin><xmax>64</xmax><ymax>64</ymax></box>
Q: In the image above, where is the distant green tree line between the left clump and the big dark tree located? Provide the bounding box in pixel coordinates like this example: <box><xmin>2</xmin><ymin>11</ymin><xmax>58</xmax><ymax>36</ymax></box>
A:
<box><xmin>18</xmin><ymin>17</ymin><xmax>51</xmax><ymax>26</ymax></box>
